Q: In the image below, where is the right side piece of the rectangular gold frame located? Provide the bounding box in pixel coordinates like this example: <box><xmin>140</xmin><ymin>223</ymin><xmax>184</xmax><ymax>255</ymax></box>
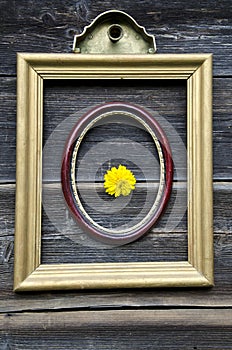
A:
<box><xmin>187</xmin><ymin>55</ymin><xmax>213</xmax><ymax>285</ymax></box>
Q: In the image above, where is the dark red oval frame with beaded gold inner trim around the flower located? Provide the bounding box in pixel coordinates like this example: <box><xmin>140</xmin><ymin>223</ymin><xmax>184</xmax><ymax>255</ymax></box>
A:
<box><xmin>61</xmin><ymin>102</ymin><xmax>173</xmax><ymax>246</ymax></box>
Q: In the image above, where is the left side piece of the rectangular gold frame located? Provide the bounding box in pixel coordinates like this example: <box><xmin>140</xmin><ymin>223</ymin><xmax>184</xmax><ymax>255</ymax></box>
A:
<box><xmin>14</xmin><ymin>55</ymin><xmax>43</xmax><ymax>286</ymax></box>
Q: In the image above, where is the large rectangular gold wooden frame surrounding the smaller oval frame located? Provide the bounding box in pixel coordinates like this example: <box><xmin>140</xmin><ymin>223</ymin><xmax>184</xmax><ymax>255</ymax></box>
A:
<box><xmin>14</xmin><ymin>54</ymin><xmax>213</xmax><ymax>292</ymax></box>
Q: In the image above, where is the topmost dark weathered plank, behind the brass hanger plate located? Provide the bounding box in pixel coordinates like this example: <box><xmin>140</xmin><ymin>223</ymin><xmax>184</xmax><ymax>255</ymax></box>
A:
<box><xmin>0</xmin><ymin>0</ymin><xmax>232</xmax><ymax>75</ymax></box>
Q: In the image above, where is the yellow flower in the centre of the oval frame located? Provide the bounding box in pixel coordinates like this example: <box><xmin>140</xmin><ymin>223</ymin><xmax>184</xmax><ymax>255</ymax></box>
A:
<box><xmin>104</xmin><ymin>164</ymin><xmax>136</xmax><ymax>197</ymax></box>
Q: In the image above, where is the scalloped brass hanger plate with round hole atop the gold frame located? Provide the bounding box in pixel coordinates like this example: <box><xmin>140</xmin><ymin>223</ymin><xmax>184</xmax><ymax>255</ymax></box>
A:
<box><xmin>73</xmin><ymin>10</ymin><xmax>156</xmax><ymax>54</ymax></box>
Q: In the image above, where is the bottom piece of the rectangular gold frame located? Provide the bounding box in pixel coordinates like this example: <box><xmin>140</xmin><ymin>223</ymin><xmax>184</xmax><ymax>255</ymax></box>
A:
<box><xmin>15</xmin><ymin>261</ymin><xmax>210</xmax><ymax>292</ymax></box>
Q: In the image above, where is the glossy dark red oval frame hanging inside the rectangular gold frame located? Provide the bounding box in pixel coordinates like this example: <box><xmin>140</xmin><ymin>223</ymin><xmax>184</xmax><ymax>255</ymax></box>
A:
<box><xmin>61</xmin><ymin>102</ymin><xmax>173</xmax><ymax>245</ymax></box>
